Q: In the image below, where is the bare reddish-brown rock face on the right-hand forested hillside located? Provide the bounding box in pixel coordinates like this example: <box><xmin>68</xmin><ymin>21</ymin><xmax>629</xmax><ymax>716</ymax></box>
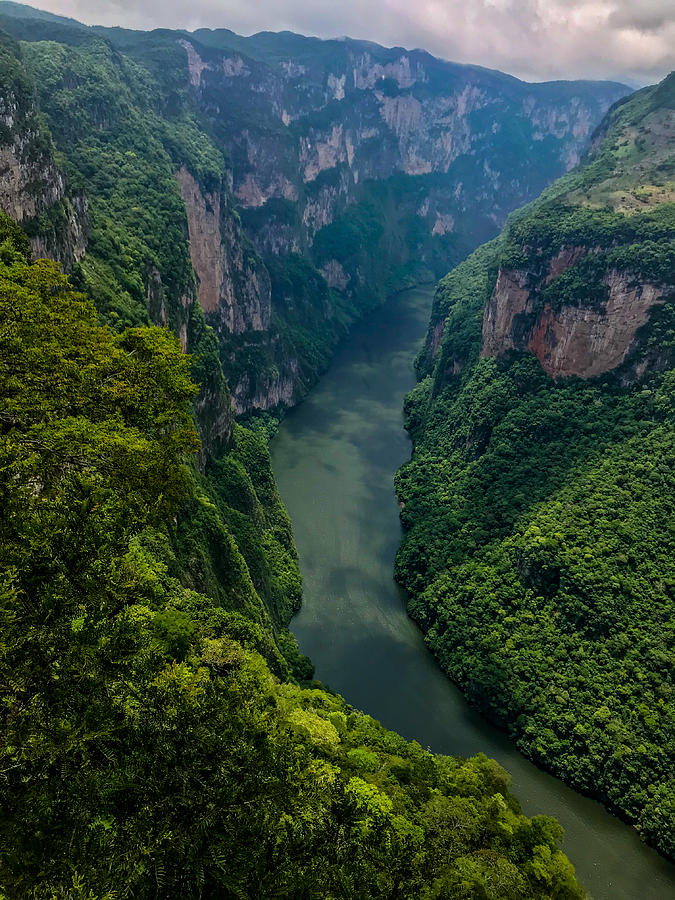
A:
<box><xmin>481</xmin><ymin>256</ymin><xmax>666</xmax><ymax>380</ymax></box>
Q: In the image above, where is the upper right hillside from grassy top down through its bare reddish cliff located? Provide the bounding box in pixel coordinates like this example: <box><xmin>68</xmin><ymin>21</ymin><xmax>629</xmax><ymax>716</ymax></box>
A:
<box><xmin>481</xmin><ymin>75</ymin><xmax>675</xmax><ymax>384</ymax></box>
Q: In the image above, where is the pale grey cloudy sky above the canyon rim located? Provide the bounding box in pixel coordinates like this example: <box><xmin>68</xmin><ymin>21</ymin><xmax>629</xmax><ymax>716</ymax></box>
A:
<box><xmin>26</xmin><ymin>0</ymin><xmax>675</xmax><ymax>85</ymax></box>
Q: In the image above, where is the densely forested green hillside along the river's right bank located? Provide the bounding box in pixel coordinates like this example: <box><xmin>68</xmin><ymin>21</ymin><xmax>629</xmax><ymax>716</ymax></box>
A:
<box><xmin>397</xmin><ymin>74</ymin><xmax>675</xmax><ymax>856</ymax></box>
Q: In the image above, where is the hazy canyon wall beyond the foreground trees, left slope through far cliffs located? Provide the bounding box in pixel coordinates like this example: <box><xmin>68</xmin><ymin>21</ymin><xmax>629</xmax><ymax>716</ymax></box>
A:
<box><xmin>0</xmin><ymin>3</ymin><xmax>627</xmax><ymax>413</ymax></box>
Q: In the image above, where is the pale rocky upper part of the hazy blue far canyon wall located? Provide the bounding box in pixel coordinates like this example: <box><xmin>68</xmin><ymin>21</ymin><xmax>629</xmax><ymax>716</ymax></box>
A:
<box><xmin>180</xmin><ymin>31</ymin><xmax>626</xmax><ymax>249</ymax></box>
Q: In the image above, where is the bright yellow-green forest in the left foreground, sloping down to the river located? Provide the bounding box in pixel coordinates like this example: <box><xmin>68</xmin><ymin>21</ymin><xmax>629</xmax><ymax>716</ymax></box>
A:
<box><xmin>0</xmin><ymin>217</ymin><xmax>583</xmax><ymax>900</ymax></box>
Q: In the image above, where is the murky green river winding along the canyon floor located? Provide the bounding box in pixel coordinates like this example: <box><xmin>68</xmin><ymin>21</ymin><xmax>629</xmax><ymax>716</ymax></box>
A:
<box><xmin>271</xmin><ymin>288</ymin><xmax>675</xmax><ymax>900</ymax></box>
